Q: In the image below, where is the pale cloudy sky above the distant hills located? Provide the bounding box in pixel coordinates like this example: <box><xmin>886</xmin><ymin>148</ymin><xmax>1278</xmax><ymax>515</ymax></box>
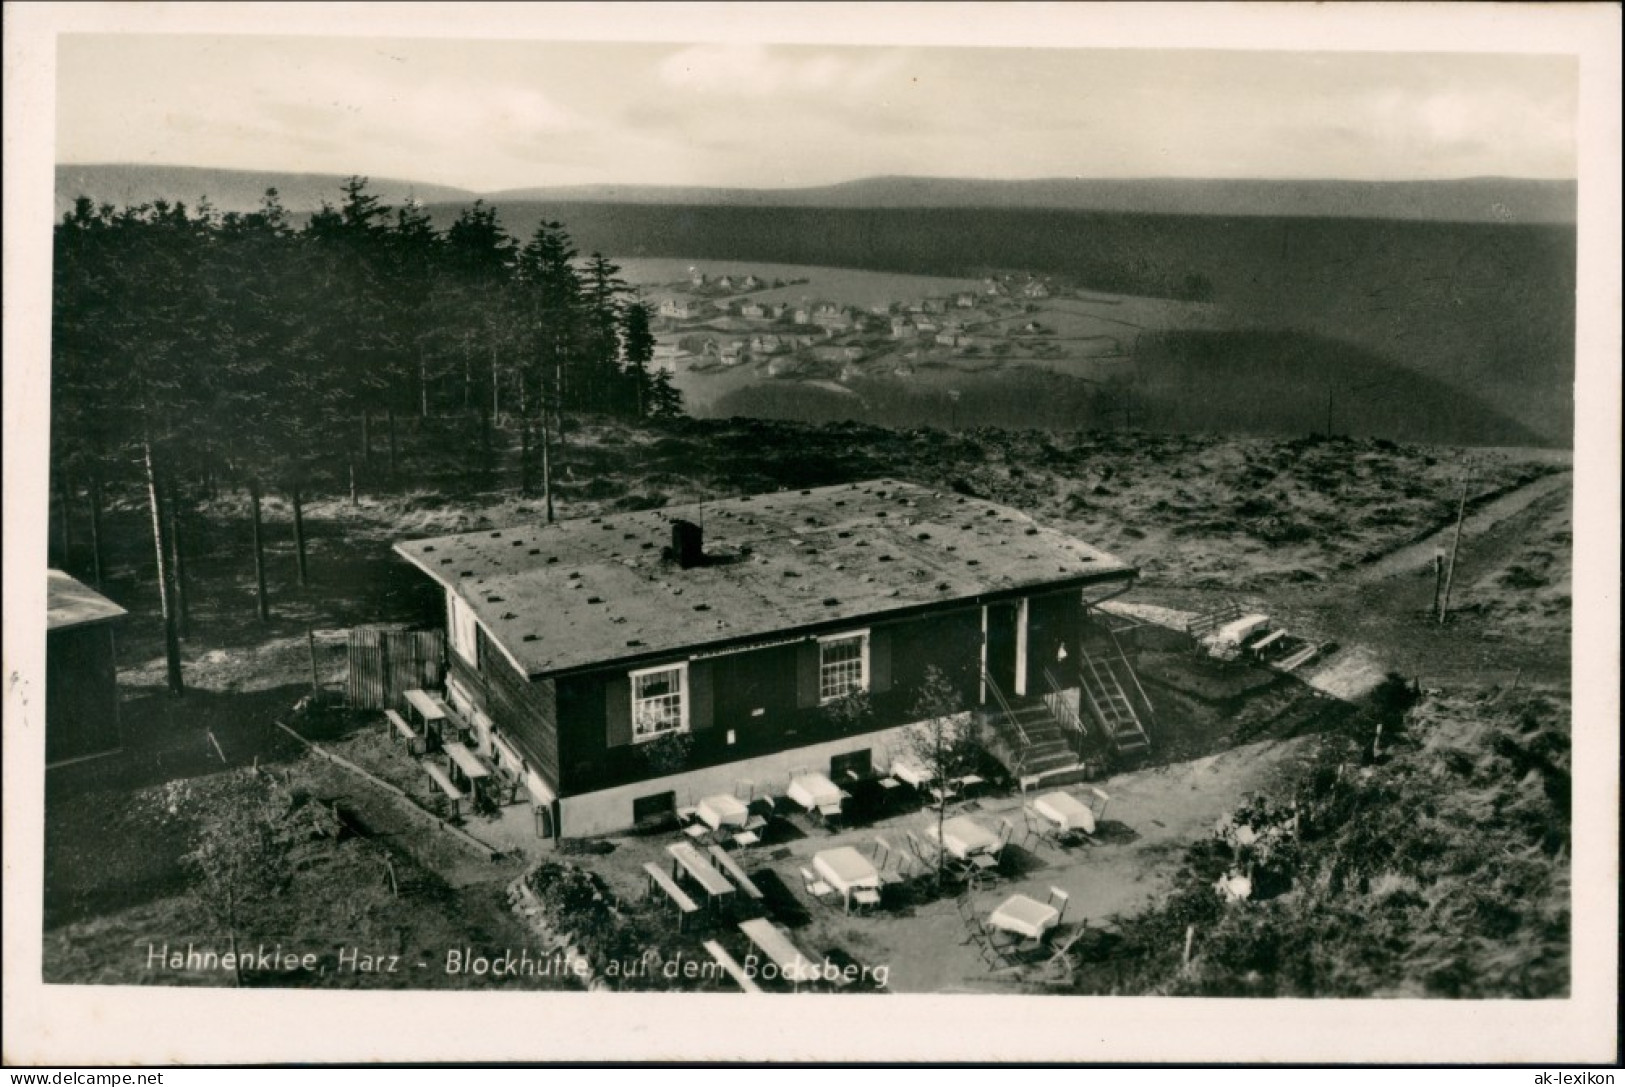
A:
<box><xmin>55</xmin><ymin>34</ymin><xmax>1578</xmax><ymax>192</ymax></box>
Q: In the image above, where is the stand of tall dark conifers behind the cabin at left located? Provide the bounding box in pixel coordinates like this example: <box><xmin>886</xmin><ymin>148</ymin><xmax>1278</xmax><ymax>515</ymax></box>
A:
<box><xmin>50</xmin><ymin>179</ymin><xmax>678</xmax><ymax>687</ymax></box>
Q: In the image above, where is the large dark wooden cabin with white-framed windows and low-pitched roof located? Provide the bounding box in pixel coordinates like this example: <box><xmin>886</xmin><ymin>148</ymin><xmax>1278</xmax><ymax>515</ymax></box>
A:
<box><xmin>395</xmin><ymin>479</ymin><xmax>1136</xmax><ymax>837</ymax></box>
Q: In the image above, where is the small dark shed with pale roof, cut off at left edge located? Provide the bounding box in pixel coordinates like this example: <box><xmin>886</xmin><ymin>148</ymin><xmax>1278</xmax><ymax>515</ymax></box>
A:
<box><xmin>46</xmin><ymin>570</ymin><xmax>128</xmax><ymax>767</ymax></box>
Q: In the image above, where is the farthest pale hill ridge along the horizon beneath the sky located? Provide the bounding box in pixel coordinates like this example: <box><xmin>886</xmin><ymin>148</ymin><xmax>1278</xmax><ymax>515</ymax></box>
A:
<box><xmin>57</xmin><ymin>164</ymin><xmax>1576</xmax><ymax>224</ymax></box>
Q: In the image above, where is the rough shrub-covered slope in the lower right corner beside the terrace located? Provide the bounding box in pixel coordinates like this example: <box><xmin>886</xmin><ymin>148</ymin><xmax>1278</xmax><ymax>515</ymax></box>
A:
<box><xmin>1076</xmin><ymin>691</ymin><xmax>1570</xmax><ymax>998</ymax></box>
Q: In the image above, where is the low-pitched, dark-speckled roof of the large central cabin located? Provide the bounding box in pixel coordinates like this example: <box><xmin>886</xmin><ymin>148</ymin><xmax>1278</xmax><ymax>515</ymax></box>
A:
<box><xmin>395</xmin><ymin>479</ymin><xmax>1136</xmax><ymax>676</ymax></box>
